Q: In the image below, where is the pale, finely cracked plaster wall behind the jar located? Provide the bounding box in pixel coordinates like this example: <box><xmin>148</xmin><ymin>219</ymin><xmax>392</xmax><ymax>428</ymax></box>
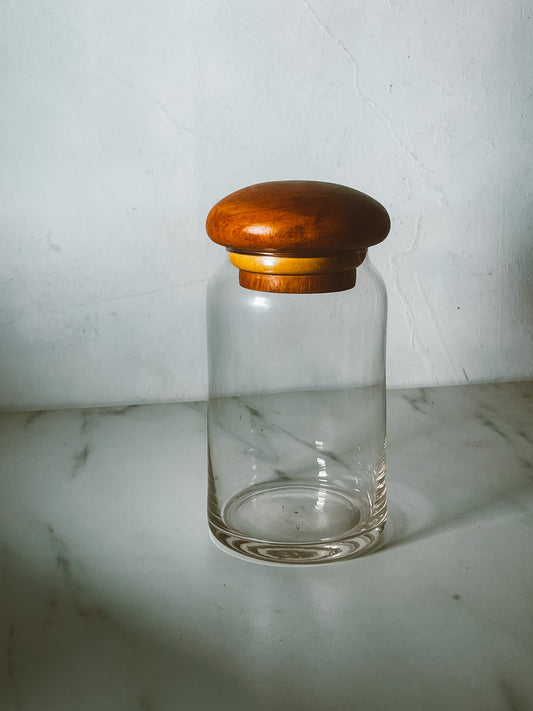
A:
<box><xmin>0</xmin><ymin>0</ymin><xmax>533</xmax><ymax>408</ymax></box>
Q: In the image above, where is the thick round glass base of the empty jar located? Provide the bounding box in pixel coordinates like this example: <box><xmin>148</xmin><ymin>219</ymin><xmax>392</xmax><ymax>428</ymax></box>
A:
<box><xmin>209</xmin><ymin>484</ymin><xmax>386</xmax><ymax>564</ymax></box>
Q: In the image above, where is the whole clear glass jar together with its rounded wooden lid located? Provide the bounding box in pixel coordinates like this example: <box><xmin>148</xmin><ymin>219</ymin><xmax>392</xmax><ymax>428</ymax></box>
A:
<box><xmin>207</xmin><ymin>181</ymin><xmax>390</xmax><ymax>564</ymax></box>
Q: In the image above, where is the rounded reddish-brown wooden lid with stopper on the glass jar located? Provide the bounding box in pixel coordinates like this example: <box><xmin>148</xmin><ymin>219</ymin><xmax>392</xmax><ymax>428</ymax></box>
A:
<box><xmin>206</xmin><ymin>180</ymin><xmax>390</xmax><ymax>294</ymax></box>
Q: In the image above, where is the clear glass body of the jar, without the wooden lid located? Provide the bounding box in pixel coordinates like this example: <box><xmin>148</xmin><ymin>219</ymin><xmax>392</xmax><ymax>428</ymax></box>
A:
<box><xmin>207</xmin><ymin>257</ymin><xmax>387</xmax><ymax>563</ymax></box>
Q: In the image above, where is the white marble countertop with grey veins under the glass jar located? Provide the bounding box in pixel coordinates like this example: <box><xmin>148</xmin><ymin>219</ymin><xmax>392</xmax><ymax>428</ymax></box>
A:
<box><xmin>0</xmin><ymin>382</ymin><xmax>533</xmax><ymax>711</ymax></box>
